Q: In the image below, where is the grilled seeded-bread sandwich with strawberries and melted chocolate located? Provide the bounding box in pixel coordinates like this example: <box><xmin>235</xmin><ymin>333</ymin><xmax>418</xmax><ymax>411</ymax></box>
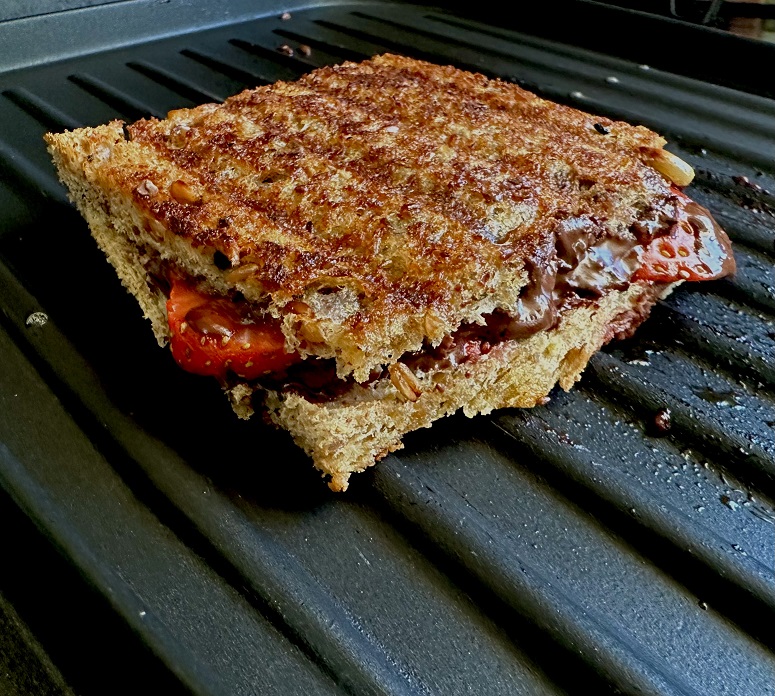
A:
<box><xmin>46</xmin><ymin>55</ymin><xmax>735</xmax><ymax>491</ymax></box>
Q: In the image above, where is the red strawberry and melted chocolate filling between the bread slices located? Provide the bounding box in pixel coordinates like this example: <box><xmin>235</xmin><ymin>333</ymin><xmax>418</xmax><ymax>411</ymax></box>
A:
<box><xmin>159</xmin><ymin>188</ymin><xmax>735</xmax><ymax>400</ymax></box>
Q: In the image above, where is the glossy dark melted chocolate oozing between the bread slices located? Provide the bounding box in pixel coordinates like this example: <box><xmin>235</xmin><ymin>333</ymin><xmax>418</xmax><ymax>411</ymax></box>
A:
<box><xmin>276</xmin><ymin>191</ymin><xmax>735</xmax><ymax>401</ymax></box>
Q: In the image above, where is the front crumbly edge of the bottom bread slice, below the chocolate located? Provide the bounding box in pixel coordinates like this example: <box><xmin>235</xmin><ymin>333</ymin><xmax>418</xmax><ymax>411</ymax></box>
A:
<box><xmin>260</xmin><ymin>283</ymin><xmax>678</xmax><ymax>491</ymax></box>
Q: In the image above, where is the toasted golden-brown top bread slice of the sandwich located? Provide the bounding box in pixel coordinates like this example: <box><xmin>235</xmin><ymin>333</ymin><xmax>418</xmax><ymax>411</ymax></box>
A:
<box><xmin>46</xmin><ymin>55</ymin><xmax>670</xmax><ymax>382</ymax></box>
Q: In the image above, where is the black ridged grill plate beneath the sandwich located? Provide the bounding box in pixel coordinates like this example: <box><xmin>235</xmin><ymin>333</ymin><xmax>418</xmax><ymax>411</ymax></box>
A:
<box><xmin>0</xmin><ymin>0</ymin><xmax>775</xmax><ymax>696</ymax></box>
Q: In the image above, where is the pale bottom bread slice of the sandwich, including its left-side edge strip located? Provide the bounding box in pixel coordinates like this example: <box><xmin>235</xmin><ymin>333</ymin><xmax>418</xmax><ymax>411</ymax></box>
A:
<box><xmin>50</xmin><ymin>151</ymin><xmax>678</xmax><ymax>491</ymax></box>
